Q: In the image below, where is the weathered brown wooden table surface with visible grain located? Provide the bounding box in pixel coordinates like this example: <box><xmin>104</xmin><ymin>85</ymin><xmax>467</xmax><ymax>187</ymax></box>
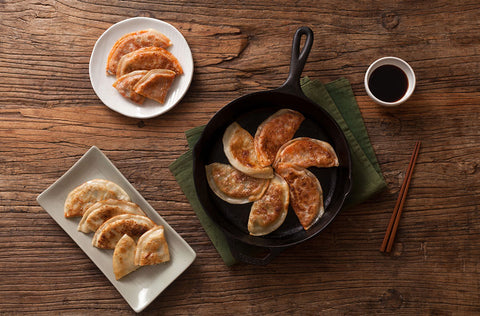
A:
<box><xmin>0</xmin><ymin>0</ymin><xmax>480</xmax><ymax>315</ymax></box>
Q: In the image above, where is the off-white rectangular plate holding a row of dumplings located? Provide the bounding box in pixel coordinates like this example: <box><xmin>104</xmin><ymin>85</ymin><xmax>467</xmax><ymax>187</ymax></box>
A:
<box><xmin>37</xmin><ymin>146</ymin><xmax>196</xmax><ymax>313</ymax></box>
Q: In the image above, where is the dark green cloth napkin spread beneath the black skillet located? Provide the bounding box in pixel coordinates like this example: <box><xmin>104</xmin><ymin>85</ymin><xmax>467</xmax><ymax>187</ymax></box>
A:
<box><xmin>169</xmin><ymin>78</ymin><xmax>386</xmax><ymax>266</ymax></box>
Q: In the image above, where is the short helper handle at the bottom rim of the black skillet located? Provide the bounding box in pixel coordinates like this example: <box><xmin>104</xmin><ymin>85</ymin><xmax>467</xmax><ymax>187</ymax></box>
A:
<box><xmin>227</xmin><ymin>237</ymin><xmax>285</xmax><ymax>266</ymax></box>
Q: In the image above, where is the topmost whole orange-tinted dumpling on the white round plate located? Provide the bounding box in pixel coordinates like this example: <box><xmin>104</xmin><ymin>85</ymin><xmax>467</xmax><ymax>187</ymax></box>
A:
<box><xmin>107</xmin><ymin>29</ymin><xmax>172</xmax><ymax>75</ymax></box>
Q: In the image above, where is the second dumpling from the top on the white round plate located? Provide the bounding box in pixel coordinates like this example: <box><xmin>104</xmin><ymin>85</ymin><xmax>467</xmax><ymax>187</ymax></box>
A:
<box><xmin>117</xmin><ymin>47</ymin><xmax>183</xmax><ymax>78</ymax></box>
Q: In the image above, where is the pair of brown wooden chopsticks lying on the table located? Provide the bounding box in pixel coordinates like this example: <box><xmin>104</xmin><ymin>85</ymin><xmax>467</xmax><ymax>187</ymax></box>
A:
<box><xmin>380</xmin><ymin>141</ymin><xmax>421</xmax><ymax>252</ymax></box>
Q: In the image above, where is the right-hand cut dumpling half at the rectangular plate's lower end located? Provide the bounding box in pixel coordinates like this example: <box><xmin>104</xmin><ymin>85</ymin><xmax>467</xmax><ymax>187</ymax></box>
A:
<box><xmin>135</xmin><ymin>225</ymin><xmax>170</xmax><ymax>266</ymax></box>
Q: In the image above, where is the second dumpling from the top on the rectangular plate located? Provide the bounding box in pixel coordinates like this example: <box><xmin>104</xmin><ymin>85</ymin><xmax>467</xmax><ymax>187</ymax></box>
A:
<box><xmin>78</xmin><ymin>199</ymin><xmax>145</xmax><ymax>233</ymax></box>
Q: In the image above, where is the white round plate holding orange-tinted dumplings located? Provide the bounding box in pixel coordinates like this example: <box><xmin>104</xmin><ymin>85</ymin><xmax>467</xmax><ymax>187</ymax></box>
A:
<box><xmin>89</xmin><ymin>17</ymin><xmax>193</xmax><ymax>119</ymax></box>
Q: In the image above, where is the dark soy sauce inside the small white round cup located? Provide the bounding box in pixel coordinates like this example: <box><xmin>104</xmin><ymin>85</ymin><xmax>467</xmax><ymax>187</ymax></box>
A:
<box><xmin>368</xmin><ymin>65</ymin><xmax>408</xmax><ymax>102</ymax></box>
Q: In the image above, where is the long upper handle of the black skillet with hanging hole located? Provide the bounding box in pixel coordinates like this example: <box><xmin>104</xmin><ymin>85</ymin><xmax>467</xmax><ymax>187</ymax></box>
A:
<box><xmin>277</xmin><ymin>26</ymin><xmax>313</xmax><ymax>96</ymax></box>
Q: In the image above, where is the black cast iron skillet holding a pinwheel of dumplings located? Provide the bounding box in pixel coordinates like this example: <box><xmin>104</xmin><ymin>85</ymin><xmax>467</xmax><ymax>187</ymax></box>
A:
<box><xmin>193</xmin><ymin>27</ymin><xmax>351</xmax><ymax>264</ymax></box>
